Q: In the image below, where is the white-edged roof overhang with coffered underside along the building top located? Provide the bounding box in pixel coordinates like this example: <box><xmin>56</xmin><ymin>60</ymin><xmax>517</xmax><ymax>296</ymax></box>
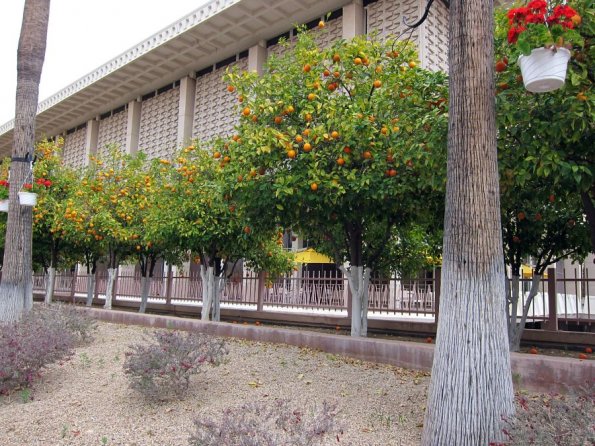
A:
<box><xmin>0</xmin><ymin>0</ymin><xmax>350</xmax><ymax>157</ymax></box>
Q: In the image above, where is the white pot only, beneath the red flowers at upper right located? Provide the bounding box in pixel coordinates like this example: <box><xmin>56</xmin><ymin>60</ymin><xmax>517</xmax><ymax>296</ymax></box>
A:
<box><xmin>519</xmin><ymin>48</ymin><xmax>570</xmax><ymax>93</ymax></box>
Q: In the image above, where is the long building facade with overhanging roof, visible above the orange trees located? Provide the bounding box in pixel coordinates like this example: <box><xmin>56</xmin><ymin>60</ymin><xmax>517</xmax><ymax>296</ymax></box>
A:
<box><xmin>0</xmin><ymin>0</ymin><xmax>448</xmax><ymax>167</ymax></box>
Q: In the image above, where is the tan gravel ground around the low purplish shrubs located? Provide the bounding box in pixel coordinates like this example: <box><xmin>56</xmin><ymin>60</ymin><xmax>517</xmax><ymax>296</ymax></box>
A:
<box><xmin>0</xmin><ymin>323</ymin><xmax>429</xmax><ymax>446</ymax></box>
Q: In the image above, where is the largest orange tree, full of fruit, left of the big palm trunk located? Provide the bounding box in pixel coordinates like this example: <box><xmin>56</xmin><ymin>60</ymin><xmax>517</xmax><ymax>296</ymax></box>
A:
<box><xmin>226</xmin><ymin>32</ymin><xmax>447</xmax><ymax>336</ymax></box>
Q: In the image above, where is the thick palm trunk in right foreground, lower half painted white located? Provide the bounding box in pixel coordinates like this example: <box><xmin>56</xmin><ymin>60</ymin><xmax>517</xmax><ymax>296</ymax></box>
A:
<box><xmin>422</xmin><ymin>0</ymin><xmax>514</xmax><ymax>446</ymax></box>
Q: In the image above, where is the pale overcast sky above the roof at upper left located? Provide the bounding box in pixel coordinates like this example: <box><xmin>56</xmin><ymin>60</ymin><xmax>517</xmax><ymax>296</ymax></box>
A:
<box><xmin>0</xmin><ymin>0</ymin><xmax>207</xmax><ymax>124</ymax></box>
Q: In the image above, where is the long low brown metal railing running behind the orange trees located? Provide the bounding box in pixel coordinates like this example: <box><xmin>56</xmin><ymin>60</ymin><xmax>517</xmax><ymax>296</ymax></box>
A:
<box><xmin>33</xmin><ymin>269</ymin><xmax>595</xmax><ymax>331</ymax></box>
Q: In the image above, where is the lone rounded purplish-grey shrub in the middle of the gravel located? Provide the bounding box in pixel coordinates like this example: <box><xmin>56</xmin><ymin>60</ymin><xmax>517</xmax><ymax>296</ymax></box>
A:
<box><xmin>124</xmin><ymin>331</ymin><xmax>228</xmax><ymax>399</ymax></box>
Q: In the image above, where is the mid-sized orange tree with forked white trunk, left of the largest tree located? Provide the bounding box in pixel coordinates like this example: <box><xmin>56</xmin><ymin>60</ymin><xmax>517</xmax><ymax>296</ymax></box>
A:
<box><xmin>146</xmin><ymin>142</ymin><xmax>292</xmax><ymax>320</ymax></box>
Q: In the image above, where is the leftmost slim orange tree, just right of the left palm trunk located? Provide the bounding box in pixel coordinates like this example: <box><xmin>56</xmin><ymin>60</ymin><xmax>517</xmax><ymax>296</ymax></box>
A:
<box><xmin>30</xmin><ymin>140</ymin><xmax>82</xmax><ymax>303</ymax></box>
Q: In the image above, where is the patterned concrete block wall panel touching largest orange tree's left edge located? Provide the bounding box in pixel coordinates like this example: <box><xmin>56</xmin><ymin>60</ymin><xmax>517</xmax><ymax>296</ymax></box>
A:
<box><xmin>192</xmin><ymin>58</ymin><xmax>248</xmax><ymax>141</ymax></box>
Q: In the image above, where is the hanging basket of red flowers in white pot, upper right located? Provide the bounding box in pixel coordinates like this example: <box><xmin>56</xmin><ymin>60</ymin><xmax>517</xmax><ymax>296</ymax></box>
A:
<box><xmin>507</xmin><ymin>0</ymin><xmax>583</xmax><ymax>93</ymax></box>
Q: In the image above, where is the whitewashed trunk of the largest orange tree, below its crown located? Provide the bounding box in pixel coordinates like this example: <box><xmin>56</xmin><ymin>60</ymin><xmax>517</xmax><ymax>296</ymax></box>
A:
<box><xmin>341</xmin><ymin>266</ymin><xmax>371</xmax><ymax>336</ymax></box>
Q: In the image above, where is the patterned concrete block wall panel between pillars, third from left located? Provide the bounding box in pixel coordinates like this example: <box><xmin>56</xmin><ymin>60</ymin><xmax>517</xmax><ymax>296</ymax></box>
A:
<box><xmin>139</xmin><ymin>87</ymin><xmax>180</xmax><ymax>158</ymax></box>
